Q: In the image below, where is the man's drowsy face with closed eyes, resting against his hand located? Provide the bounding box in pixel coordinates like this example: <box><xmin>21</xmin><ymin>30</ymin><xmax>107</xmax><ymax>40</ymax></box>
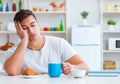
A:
<box><xmin>21</xmin><ymin>15</ymin><xmax>40</xmax><ymax>40</ymax></box>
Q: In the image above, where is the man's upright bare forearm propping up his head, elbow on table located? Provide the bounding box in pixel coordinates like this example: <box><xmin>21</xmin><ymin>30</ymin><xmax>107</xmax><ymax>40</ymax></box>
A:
<box><xmin>4</xmin><ymin>39</ymin><xmax>28</xmax><ymax>75</ymax></box>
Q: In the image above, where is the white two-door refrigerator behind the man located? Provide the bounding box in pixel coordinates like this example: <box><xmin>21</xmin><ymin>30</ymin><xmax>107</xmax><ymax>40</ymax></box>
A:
<box><xmin>71</xmin><ymin>25</ymin><xmax>101</xmax><ymax>71</ymax></box>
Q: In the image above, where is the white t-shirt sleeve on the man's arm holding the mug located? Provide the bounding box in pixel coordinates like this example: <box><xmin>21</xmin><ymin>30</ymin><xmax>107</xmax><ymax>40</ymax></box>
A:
<box><xmin>61</xmin><ymin>39</ymin><xmax>78</xmax><ymax>61</ymax></box>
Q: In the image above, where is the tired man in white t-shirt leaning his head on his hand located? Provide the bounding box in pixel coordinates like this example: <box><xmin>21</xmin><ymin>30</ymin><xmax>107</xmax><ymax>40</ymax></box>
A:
<box><xmin>4</xmin><ymin>10</ymin><xmax>88</xmax><ymax>75</ymax></box>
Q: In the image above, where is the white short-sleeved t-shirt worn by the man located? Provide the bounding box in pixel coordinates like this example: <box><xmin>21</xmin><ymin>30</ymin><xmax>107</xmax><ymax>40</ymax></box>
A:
<box><xmin>3</xmin><ymin>36</ymin><xmax>77</xmax><ymax>73</ymax></box>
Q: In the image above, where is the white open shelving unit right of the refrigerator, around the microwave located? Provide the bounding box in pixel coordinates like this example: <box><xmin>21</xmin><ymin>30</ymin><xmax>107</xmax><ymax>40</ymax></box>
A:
<box><xmin>100</xmin><ymin>0</ymin><xmax>120</xmax><ymax>70</ymax></box>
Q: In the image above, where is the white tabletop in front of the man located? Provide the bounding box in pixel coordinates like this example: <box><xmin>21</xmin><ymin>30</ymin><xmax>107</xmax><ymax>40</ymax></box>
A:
<box><xmin>0</xmin><ymin>72</ymin><xmax>120</xmax><ymax>84</ymax></box>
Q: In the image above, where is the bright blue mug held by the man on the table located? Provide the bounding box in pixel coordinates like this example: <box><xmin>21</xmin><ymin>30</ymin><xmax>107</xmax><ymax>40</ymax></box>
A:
<box><xmin>48</xmin><ymin>63</ymin><xmax>62</xmax><ymax>78</ymax></box>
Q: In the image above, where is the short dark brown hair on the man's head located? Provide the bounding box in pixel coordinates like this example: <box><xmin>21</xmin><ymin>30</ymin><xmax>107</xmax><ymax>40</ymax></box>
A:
<box><xmin>14</xmin><ymin>9</ymin><xmax>37</xmax><ymax>22</ymax></box>
